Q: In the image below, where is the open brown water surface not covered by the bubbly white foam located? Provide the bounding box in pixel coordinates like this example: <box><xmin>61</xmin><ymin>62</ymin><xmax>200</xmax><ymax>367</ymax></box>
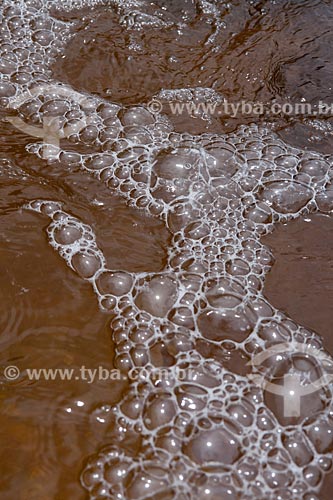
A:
<box><xmin>0</xmin><ymin>0</ymin><xmax>333</xmax><ymax>500</ymax></box>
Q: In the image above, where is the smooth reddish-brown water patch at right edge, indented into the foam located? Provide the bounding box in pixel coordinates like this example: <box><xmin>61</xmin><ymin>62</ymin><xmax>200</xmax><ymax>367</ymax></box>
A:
<box><xmin>265</xmin><ymin>215</ymin><xmax>333</xmax><ymax>351</ymax></box>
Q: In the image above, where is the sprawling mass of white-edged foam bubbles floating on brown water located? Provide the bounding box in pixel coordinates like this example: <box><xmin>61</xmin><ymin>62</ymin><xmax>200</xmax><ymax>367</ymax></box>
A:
<box><xmin>0</xmin><ymin>0</ymin><xmax>333</xmax><ymax>500</ymax></box>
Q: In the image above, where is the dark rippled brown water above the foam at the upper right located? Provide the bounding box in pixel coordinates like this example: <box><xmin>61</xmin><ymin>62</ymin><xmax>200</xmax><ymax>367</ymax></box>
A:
<box><xmin>54</xmin><ymin>0</ymin><xmax>333</xmax><ymax>141</ymax></box>
